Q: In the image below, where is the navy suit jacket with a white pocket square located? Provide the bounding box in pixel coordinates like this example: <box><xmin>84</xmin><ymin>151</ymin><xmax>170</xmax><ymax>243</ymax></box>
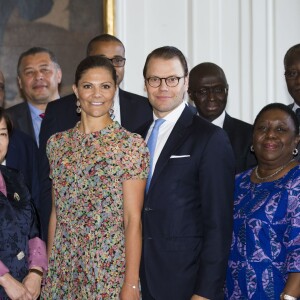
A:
<box><xmin>139</xmin><ymin>107</ymin><xmax>235</xmax><ymax>300</ymax></box>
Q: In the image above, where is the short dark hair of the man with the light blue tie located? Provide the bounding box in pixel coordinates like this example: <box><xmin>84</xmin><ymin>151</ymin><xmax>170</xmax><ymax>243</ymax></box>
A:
<box><xmin>143</xmin><ymin>46</ymin><xmax>189</xmax><ymax>78</ymax></box>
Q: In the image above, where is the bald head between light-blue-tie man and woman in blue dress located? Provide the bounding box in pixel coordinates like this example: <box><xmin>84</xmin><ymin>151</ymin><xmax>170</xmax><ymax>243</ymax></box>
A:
<box><xmin>188</xmin><ymin>62</ymin><xmax>228</xmax><ymax>122</ymax></box>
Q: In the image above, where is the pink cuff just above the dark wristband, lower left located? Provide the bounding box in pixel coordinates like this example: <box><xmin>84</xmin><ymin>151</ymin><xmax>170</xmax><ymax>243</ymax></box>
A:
<box><xmin>28</xmin><ymin>237</ymin><xmax>48</xmax><ymax>271</ymax></box>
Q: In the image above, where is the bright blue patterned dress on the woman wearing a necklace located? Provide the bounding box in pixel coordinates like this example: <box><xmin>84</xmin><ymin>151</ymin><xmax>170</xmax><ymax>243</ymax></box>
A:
<box><xmin>225</xmin><ymin>166</ymin><xmax>300</xmax><ymax>300</ymax></box>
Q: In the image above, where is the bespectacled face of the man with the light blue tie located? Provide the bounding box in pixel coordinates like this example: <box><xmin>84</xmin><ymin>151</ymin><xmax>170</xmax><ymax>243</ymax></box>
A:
<box><xmin>145</xmin><ymin>57</ymin><xmax>188</xmax><ymax>118</ymax></box>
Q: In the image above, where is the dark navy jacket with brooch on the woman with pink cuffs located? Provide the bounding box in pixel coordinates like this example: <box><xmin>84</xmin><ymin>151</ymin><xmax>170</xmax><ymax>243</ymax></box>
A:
<box><xmin>0</xmin><ymin>165</ymin><xmax>39</xmax><ymax>299</ymax></box>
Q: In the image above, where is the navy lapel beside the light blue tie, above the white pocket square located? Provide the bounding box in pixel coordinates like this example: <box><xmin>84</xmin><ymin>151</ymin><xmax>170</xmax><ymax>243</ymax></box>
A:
<box><xmin>149</xmin><ymin>107</ymin><xmax>195</xmax><ymax>192</ymax></box>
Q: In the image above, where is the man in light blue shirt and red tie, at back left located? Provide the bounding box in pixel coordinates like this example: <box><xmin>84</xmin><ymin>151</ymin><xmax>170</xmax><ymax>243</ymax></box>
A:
<box><xmin>7</xmin><ymin>47</ymin><xmax>62</xmax><ymax>145</ymax></box>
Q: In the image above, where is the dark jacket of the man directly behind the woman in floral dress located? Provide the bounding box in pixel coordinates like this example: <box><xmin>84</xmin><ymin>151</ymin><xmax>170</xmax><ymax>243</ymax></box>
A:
<box><xmin>39</xmin><ymin>89</ymin><xmax>153</xmax><ymax>240</ymax></box>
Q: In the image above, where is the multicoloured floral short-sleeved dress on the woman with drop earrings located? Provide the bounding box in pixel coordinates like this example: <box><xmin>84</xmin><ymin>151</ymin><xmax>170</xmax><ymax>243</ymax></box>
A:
<box><xmin>42</xmin><ymin>122</ymin><xmax>149</xmax><ymax>300</ymax></box>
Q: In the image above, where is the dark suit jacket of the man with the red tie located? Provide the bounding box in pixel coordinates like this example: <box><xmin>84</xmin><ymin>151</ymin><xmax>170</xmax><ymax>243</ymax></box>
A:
<box><xmin>6</xmin><ymin>102</ymin><xmax>35</xmax><ymax>141</ymax></box>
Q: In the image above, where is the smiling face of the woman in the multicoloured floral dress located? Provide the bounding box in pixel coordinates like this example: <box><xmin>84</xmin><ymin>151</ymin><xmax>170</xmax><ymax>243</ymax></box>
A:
<box><xmin>73</xmin><ymin>67</ymin><xmax>116</xmax><ymax>118</ymax></box>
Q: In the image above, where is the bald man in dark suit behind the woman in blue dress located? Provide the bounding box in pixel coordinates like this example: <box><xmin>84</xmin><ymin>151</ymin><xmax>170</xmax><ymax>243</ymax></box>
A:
<box><xmin>188</xmin><ymin>62</ymin><xmax>257</xmax><ymax>173</ymax></box>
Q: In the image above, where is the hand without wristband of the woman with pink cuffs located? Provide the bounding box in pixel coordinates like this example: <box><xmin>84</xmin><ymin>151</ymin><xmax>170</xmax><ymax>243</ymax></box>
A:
<box><xmin>0</xmin><ymin>273</ymin><xmax>32</xmax><ymax>300</ymax></box>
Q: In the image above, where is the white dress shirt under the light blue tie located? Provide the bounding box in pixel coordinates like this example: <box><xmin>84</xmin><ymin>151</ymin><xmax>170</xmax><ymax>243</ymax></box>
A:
<box><xmin>146</xmin><ymin>102</ymin><xmax>186</xmax><ymax>175</ymax></box>
